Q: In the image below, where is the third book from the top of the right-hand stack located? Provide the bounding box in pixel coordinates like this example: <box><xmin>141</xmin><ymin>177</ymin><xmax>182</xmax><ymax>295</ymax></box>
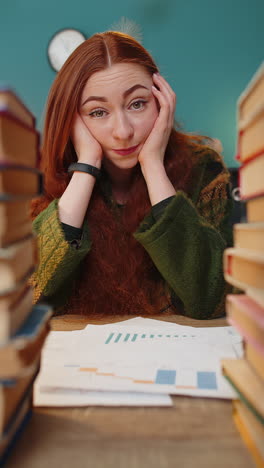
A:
<box><xmin>239</xmin><ymin>154</ymin><xmax>264</xmax><ymax>200</ymax></box>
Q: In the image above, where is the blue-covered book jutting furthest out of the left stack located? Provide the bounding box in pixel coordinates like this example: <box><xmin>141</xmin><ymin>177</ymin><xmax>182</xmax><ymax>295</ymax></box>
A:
<box><xmin>0</xmin><ymin>304</ymin><xmax>52</xmax><ymax>379</ymax></box>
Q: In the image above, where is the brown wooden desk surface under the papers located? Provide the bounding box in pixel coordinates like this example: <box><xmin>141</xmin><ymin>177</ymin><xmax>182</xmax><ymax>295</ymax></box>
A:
<box><xmin>6</xmin><ymin>316</ymin><xmax>255</xmax><ymax>468</ymax></box>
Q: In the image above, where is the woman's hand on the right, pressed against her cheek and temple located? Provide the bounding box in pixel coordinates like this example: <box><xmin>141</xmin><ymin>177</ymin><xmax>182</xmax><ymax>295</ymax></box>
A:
<box><xmin>138</xmin><ymin>73</ymin><xmax>176</xmax><ymax>169</ymax></box>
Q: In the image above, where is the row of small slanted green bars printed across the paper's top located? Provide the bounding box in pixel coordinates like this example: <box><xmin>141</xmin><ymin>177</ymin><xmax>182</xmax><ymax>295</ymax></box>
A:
<box><xmin>105</xmin><ymin>332</ymin><xmax>196</xmax><ymax>344</ymax></box>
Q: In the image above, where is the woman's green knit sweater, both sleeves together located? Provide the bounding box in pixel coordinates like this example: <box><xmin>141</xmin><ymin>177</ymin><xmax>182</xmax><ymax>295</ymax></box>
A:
<box><xmin>32</xmin><ymin>148</ymin><xmax>232</xmax><ymax>319</ymax></box>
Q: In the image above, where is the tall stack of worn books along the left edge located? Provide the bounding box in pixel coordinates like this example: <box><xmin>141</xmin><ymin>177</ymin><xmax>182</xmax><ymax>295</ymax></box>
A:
<box><xmin>0</xmin><ymin>88</ymin><xmax>51</xmax><ymax>464</ymax></box>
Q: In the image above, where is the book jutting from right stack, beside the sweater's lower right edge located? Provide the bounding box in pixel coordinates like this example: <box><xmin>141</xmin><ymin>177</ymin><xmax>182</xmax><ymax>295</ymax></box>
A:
<box><xmin>224</xmin><ymin>248</ymin><xmax>264</xmax><ymax>290</ymax></box>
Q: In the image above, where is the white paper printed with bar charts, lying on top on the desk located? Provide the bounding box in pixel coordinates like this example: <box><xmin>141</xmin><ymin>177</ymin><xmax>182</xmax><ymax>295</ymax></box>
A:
<box><xmin>39</xmin><ymin>318</ymin><xmax>242</xmax><ymax>398</ymax></box>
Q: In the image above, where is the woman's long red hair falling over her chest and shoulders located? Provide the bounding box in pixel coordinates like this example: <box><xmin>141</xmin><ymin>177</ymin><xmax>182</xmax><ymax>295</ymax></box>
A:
<box><xmin>31</xmin><ymin>31</ymin><xmax>210</xmax><ymax>314</ymax></box>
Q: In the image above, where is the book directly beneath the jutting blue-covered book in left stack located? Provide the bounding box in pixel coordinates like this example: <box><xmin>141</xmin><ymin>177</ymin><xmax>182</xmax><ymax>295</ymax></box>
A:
<box><xmin>0</xmin><ymin>359</ymin><xmax>40</xmax><ymax>437</ymax></box>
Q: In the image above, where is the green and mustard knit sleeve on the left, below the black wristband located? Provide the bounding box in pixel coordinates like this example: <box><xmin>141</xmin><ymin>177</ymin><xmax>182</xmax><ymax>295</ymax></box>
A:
<box><xmin>31</xmin><ymin>200</ymin><xmax>91</xmax><ymax>305</ymax></box>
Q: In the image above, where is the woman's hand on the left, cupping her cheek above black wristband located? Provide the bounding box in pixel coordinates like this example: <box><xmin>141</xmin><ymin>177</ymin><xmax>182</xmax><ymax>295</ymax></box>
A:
<box><xmin>71</xmin><ymin>113</ymin><xmax>103</xmax><ymax>169</ymax></box>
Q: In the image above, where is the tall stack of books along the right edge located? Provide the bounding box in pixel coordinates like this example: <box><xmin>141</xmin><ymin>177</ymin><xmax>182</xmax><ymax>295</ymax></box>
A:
<box><xmin>222</xmin><ymin>64</ymin><xmax>264</xmax><ymax>467</ymax></box>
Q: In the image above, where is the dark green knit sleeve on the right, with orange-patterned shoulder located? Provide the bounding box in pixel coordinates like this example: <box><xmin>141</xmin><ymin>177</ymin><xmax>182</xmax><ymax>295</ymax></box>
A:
<box><xmin>134</xmin><ymin>149</ymin><xmax>232</xmax><ymax>319</ymax></box>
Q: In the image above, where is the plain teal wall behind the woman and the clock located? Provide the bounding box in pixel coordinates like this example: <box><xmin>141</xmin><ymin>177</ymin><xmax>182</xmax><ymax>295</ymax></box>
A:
<box><xmin>0</xmin><ymin>0</ymin><xmax>264</xmax><ymax>166</ymax></box>
